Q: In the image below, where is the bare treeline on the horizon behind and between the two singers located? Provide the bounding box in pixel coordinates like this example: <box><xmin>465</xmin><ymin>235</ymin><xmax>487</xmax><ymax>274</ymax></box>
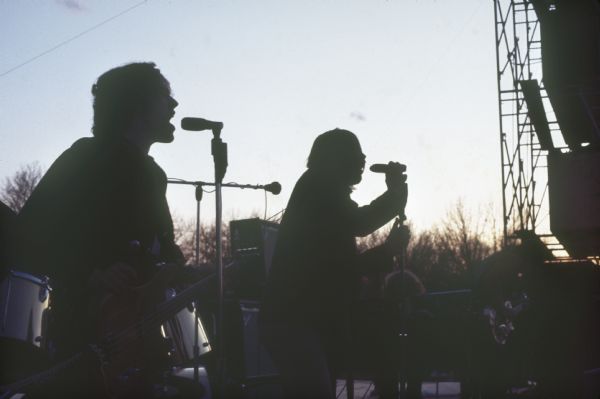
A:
<box><xmin>173</xmin><ymin>200</ymin><xmax>502</xmax><ymax>291</ymax></box>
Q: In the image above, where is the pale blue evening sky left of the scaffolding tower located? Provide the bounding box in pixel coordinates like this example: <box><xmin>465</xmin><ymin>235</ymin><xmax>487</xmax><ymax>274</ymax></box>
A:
<box><xmin>0</xmin><ymin>0</ymin><xmax>501</xmax><ymax>233</ymax></box>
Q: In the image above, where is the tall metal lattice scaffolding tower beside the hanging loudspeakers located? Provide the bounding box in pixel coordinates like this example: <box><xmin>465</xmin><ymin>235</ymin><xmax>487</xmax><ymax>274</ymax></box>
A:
<box><xmin>494</xmin><ymin>0</ymin><xmax>560</xmax><ymax>247</ymax></box>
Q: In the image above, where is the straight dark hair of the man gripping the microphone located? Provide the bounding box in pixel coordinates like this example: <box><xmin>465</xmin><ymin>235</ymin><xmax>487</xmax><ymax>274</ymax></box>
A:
<box><xmin>306</xmin><ymin>128</ymin><xmax>358</xmax><ymax>169</ymax></box>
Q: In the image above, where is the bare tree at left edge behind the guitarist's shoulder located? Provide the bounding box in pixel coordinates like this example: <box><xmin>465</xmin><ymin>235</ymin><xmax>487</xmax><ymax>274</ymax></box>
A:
<box><xmin>0</xmin><ymin>162</ymin><xmax>43</xmax><ymax>213</ymax></box>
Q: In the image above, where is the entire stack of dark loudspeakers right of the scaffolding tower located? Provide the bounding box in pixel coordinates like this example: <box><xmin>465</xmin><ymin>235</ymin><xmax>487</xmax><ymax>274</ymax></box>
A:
<box><xmin>519</xmin><ymin>0</ymin><xmax>600</xmax><ymax>258</ymax></box>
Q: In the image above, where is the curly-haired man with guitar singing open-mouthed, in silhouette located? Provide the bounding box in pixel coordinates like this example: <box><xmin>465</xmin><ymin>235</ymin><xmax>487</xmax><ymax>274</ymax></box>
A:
<box><xmin>19</xmin><ymin>63</ymin><xmax>182</xmax><ymax>394</ymax></box>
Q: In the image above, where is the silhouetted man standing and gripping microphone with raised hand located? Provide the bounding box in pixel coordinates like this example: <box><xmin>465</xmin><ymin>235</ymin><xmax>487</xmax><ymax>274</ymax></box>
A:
<box><xmin>260</xmin><ymin>129</ymin><xmax>407</xmax><ymax>398</ymax></box>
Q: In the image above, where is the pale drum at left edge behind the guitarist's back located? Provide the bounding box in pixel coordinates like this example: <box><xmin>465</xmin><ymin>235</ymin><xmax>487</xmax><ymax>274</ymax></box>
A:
<box><xmin>0</xmin><ymin>270</ymin><xmax>51</xmax><ymax>349</ymax></box>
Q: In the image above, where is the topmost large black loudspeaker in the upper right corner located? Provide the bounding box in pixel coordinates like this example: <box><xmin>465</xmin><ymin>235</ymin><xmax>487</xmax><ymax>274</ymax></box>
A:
<box><xmin>531</xmin><ymin>0</ymin><xmax>600</xmax><ymax>150</ymax></box>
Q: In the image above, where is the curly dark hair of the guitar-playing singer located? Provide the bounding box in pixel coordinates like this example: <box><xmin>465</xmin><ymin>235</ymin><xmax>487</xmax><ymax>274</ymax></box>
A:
<box><xmin>92</xmin><ymin>62</ymin><xmax>171</xmax><ymax>137</ymax></box>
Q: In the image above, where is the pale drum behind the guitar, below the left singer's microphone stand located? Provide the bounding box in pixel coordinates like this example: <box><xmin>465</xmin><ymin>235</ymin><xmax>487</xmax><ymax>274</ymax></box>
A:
<box><xmin>161</xmin><ymin>288</ymin><xmax>211</xmax><ymax>366</ymax></box>
